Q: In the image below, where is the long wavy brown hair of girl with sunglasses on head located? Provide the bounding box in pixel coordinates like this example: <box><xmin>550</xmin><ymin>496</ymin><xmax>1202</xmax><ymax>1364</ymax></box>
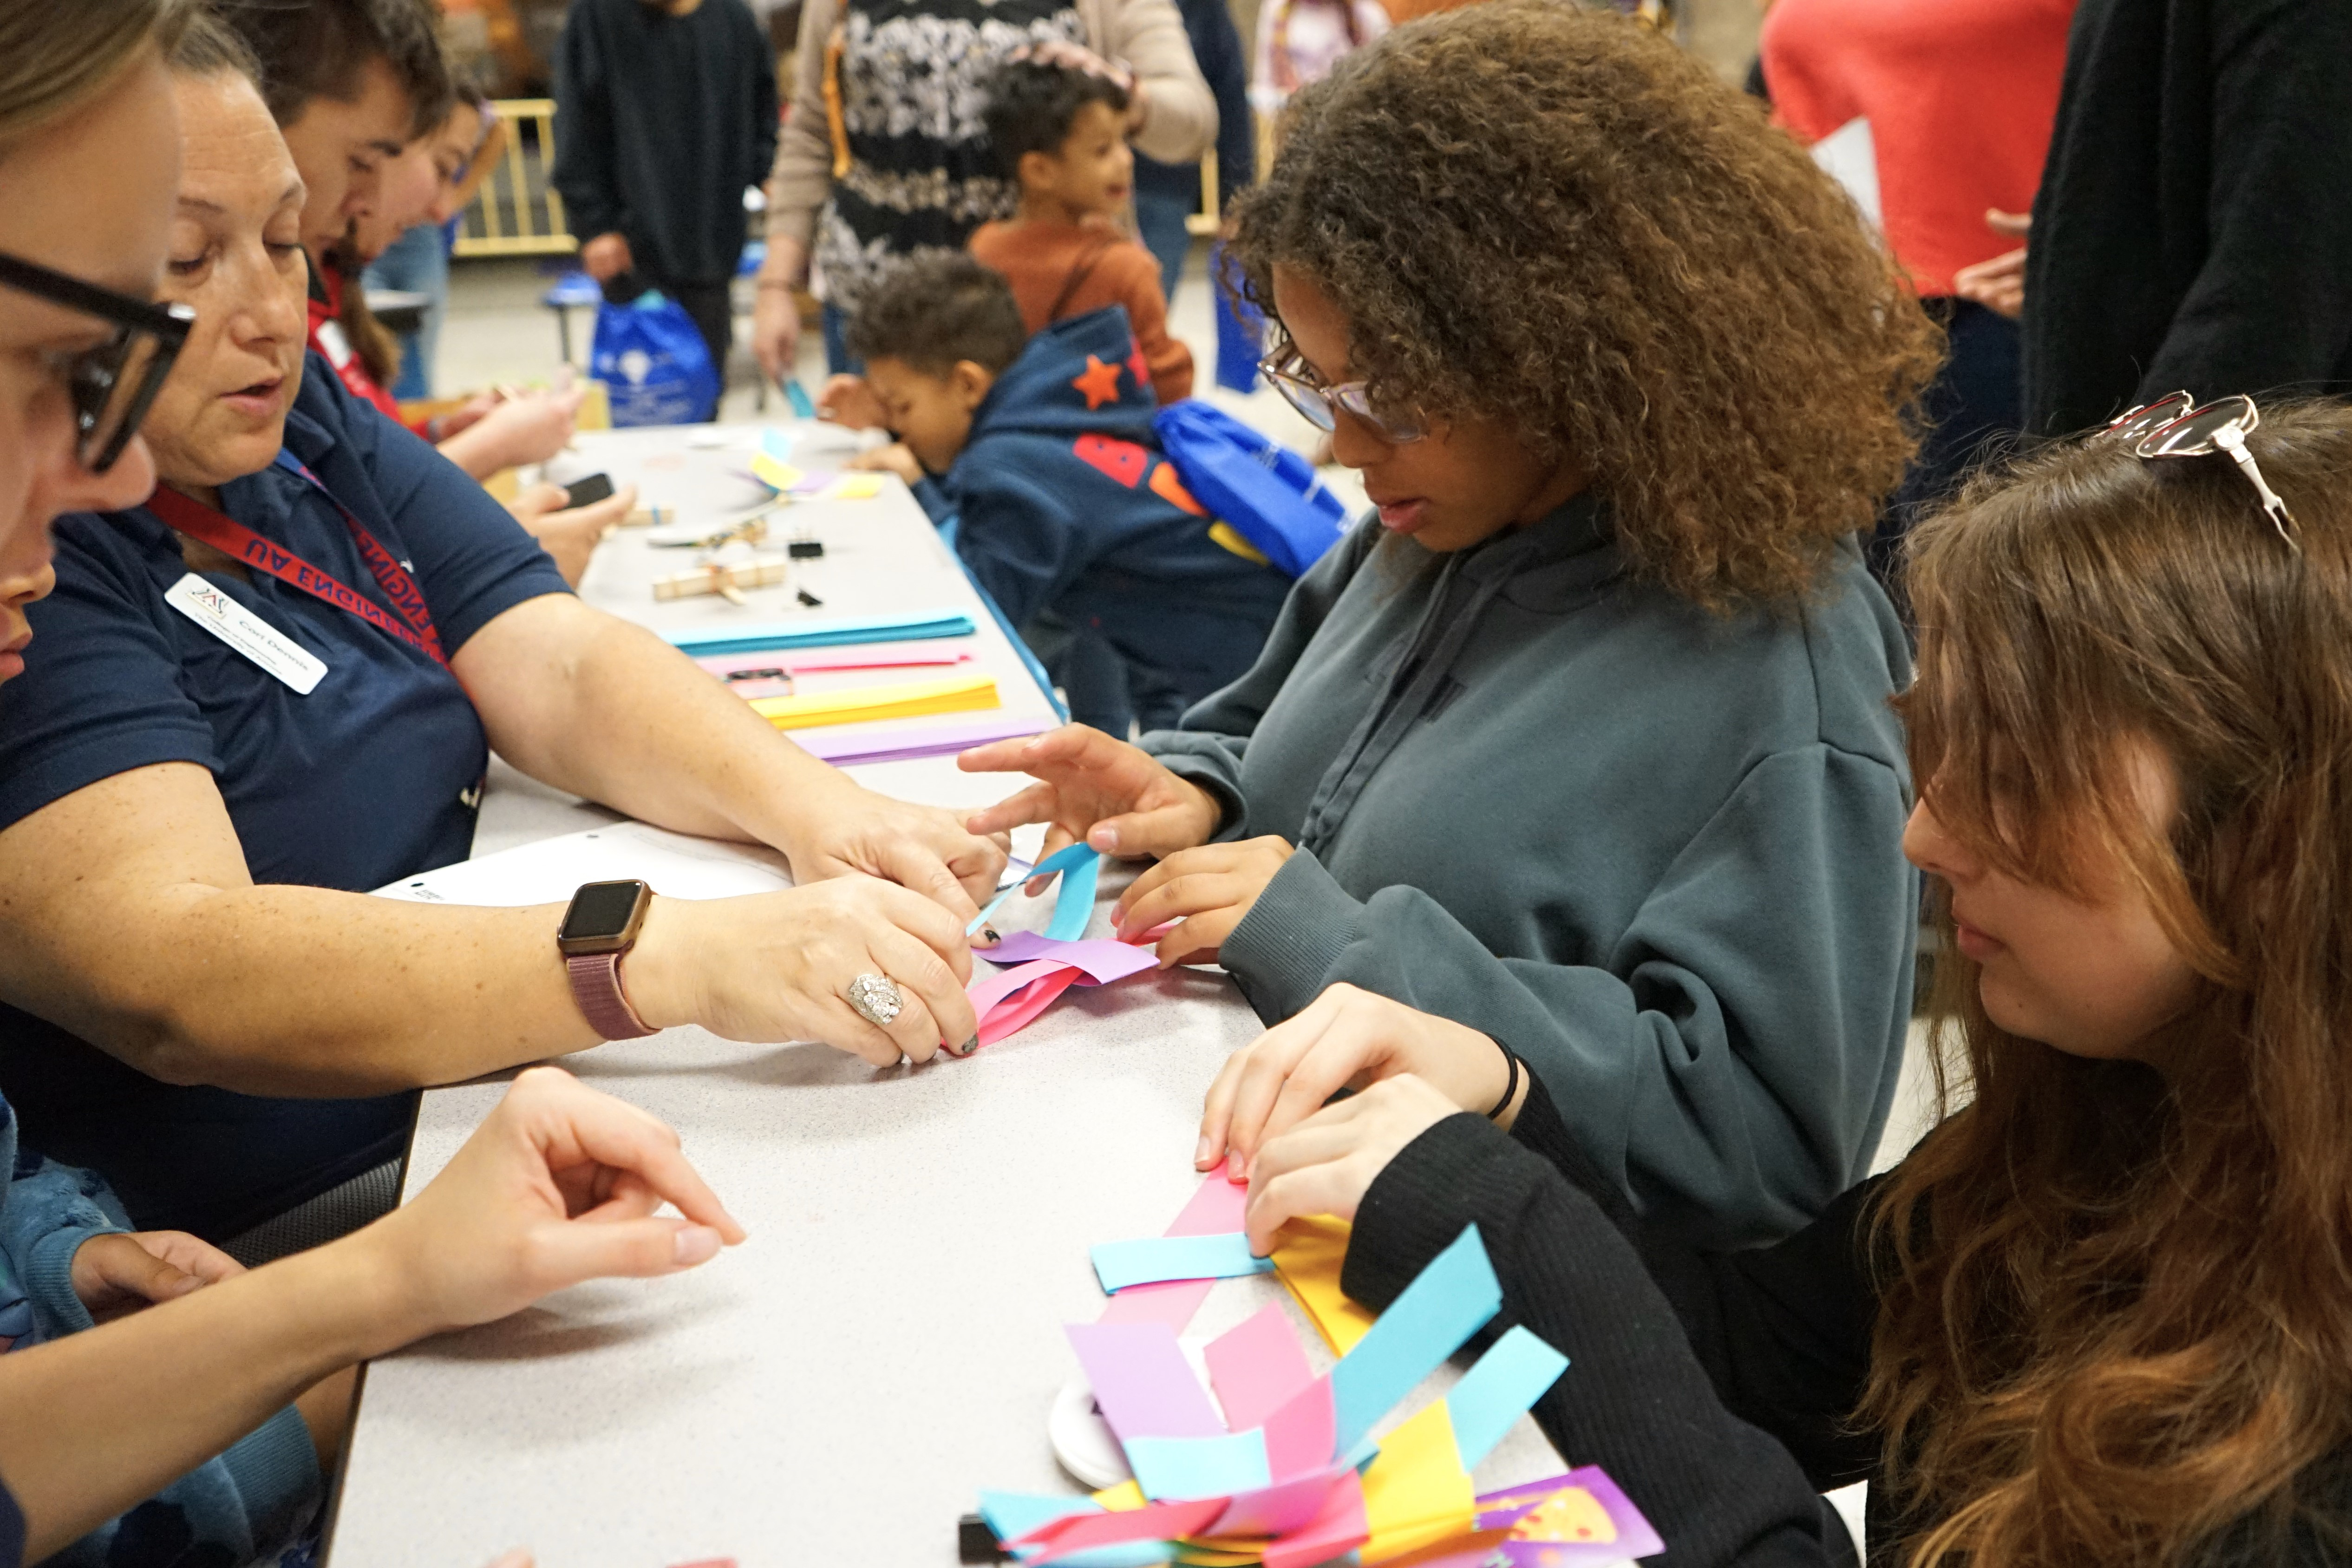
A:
<box><xmin>1861</xmin><ymin>405</ymin><xmax>2352</xmax><ymax>1568</ymax></box>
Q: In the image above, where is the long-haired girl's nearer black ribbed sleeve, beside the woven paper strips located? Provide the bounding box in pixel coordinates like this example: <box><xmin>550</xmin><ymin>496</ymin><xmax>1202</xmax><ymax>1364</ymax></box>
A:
<box><xmin>1340</xmin><ymin>1112</ymin><xmax>1851</xmax><ymax>1568</ymax></box>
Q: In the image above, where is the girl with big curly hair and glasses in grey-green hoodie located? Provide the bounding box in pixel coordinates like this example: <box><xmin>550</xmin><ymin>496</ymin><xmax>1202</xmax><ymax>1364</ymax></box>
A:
<box><xmin>964</xmin><ymin>0</ymin><xmax>1936</xmax><ymax>1244</ymax></box>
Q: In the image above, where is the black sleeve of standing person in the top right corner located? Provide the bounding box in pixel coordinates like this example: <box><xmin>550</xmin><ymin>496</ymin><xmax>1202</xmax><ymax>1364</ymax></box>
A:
<box><xmin>2136</xmin><ymin>0</ymin><xmax>2352</xmax><ymax>402</ymax></box>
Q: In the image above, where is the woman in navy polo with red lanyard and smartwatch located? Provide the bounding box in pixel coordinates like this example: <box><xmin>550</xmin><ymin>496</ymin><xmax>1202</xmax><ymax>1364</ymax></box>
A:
<box><xmin>0</xmin><ymin>43</ymin><xmax>1004</xmax><ymax>1239</ymax></box>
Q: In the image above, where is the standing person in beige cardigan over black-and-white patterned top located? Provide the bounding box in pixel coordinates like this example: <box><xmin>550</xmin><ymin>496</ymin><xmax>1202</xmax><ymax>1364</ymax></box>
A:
<box><xmin>752</xmin><ymin>0</ymin><xmax>1216</xmax><ymax>390</ymax></box>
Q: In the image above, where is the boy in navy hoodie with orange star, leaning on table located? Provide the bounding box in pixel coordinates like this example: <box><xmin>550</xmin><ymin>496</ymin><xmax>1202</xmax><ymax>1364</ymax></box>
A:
<box><xmin>849</xmin><ymin>254</ymin><xmax>1289</xmax><ymax>740</ymax></box>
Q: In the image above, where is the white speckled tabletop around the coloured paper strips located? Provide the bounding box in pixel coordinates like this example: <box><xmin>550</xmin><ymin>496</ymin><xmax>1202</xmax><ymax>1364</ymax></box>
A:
<box><xmin>329</xmin><ymin>435</ymin><xmax>1559</xmax><ymax>1568</ymax></box>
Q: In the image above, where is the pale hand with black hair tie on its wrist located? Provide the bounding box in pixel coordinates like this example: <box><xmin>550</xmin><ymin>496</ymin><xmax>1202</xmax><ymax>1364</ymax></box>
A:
<box><xmin>1192</xmin><ymin>980</ymin><xmax>1527</xmax><ymax>1180</ymax></box>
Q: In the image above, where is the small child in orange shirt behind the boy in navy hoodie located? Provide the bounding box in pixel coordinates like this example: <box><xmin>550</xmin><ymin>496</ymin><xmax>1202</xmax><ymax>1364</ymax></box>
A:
<box><xmin>971</xmin><ymin>61</ymin><xmax>1192</xmax><ymax>405</ymax></box>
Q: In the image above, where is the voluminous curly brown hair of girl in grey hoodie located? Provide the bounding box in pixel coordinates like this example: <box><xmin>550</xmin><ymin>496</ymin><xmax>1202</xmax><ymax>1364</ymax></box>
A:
<box><xmin>1233</xmin><ymin>0</ymin><xmax>1943</xmax><ymax>609</ymax></box>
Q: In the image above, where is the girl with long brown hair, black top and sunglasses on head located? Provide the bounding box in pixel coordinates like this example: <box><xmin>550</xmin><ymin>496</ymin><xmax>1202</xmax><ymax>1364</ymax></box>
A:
<box><xmin>1249</xmin><ymin>399</ymin><xmax>2352</xmax><ymax>1568</ymax></box>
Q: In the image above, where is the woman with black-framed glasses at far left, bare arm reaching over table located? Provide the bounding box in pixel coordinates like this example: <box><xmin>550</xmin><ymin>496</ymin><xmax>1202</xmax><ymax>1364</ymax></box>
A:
<box><xmin>0</xmin><ymin>0</ymin><xmax>743</xmax><ymax>1568</ymax></box>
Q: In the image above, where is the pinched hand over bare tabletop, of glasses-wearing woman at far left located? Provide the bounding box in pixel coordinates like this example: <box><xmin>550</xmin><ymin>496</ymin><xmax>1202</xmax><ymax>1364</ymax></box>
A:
<box><xmin>350</xmin><ymin>1067</ymin><xmax>743</xmax><ymax>1342</ymax></box>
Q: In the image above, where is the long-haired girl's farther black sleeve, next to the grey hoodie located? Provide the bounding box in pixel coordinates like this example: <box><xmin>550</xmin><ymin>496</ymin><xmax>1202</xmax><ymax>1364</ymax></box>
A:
<box><xmin>1510</xmin><ymin>1079</ymin><xmax>1879</xmax><ymax>1490</ymax></box>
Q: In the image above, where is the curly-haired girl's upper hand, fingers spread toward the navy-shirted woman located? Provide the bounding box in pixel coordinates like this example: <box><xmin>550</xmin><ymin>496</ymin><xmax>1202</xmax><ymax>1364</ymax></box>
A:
<box><xmin>955</xmin><ymin>724</ymin><xmax>1221</xmax><ymax>893</ymax></box>
